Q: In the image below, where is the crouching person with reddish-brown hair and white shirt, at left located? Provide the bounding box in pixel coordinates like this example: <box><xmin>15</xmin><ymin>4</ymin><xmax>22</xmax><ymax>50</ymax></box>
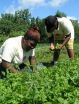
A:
<box><xmin>0</xmin><ymin>27</ymin><xmax>40</xmax><ymax>78</ymax></box>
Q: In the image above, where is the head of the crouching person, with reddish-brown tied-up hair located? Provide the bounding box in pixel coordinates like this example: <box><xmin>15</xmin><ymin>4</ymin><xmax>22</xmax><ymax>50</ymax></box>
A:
<box><xmin>22</xmin><ymin>27</ymin><xmax>40</xmax><ymax>51</ymax></box>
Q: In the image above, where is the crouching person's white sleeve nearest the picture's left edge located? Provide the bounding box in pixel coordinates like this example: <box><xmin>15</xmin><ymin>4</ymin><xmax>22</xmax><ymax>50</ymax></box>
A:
<box><xmin>2</xmin><ymin>43</ymin><xmax>16</xmax><ymax>62</ymax></box>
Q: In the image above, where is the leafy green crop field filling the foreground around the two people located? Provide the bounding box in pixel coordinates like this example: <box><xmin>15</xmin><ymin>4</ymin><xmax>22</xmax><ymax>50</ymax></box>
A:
<box><xmin>0</xmin><ymin>43</ymin><xmax>79</xmax><ymax>104</ymax></box>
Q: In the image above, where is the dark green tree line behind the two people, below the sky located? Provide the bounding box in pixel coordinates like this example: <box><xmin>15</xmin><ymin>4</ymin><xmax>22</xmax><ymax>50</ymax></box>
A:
<box><xmin>0</xmin><ymin>9</ymin><xmax>79</xmax><ymax>43</ymax></box>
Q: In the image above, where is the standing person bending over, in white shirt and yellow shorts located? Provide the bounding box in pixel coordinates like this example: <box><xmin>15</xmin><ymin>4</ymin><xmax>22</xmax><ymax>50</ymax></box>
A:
<box><xmin>45</xmin><ymin>15</ymin><xmax>74</xmax><ymax>64</ymax></box>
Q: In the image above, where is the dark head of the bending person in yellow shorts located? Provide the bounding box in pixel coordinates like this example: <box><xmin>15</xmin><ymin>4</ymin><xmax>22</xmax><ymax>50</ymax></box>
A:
<box><xmin>44</xmin><ymin>15</ymin><xmax>58</xmax><ymax>33</ymax></box>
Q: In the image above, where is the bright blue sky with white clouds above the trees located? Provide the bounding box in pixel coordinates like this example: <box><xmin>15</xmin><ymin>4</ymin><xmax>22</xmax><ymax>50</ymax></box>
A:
<box><xmin>0</xmin><ymin>0</ymin><xmax>79</xmax><ymax>20</ymax></box>
